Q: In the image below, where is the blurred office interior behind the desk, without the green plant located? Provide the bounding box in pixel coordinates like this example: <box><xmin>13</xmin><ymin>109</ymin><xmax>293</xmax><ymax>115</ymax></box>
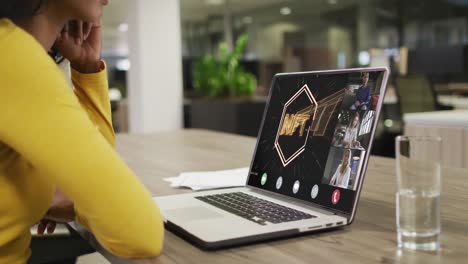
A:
<box><xmin>98</xmin><ymin>0</ymin><xmax>468</xmax><ymax>156</ymax></box>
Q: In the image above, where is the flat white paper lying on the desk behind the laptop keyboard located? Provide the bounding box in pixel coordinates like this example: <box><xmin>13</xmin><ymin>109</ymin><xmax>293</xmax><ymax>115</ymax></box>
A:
<box><xmin>164</xmin><ymin>168</ymin><xmax>249</xmax><ymax>191</ymax></box>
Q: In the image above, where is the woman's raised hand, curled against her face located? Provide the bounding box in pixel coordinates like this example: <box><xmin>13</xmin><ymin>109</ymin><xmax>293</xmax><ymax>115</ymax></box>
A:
<box><xmin>54</xmin><ymin>20</ymin><xmax>102</xmax><ymax>73</ymax></box>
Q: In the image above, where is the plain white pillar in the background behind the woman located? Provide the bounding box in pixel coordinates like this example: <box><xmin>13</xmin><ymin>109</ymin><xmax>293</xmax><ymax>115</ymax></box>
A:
<box><xmin>128</xmin><ymin>0</ymin><xmax>183</xmax><ymax>133</ymax></box>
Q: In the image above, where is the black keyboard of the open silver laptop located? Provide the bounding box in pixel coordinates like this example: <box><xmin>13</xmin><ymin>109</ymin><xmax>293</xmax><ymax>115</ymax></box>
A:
<box><xmin>195</xmin><ymin>192</ymin><xmax>316</xmax><ymax>225</ymax></box>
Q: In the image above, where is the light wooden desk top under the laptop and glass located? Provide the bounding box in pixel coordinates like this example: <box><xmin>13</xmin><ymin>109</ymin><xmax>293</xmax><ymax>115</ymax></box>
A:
<box><xmin>81</xmin><ymin>130</ymin><xmax>468</xmax><ymax>264</ymax></box>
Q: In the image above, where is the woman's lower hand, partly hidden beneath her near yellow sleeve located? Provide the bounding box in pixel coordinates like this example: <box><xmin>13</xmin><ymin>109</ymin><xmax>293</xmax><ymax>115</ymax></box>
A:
<box><xmin>37</xmin><ymin>189</ymin><xmax>75</xmax><ymax>235</ymax></box>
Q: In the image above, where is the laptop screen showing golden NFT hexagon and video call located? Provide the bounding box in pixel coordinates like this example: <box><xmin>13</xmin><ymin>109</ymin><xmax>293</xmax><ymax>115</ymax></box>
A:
<box><xmin>248</xmin><ymin>69</ymin><xmax>385</xmax><ymax>213</ymax></box>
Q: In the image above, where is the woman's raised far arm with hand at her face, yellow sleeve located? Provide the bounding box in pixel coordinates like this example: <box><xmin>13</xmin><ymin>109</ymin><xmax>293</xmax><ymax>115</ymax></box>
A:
<box><xmin>54</xmin><ymin>21</ymin><xmax>115</xmax><ymax>146</ymax></box>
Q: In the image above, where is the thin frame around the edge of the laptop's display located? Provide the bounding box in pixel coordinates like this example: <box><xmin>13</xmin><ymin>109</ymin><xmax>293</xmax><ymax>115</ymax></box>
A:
<box><xmin>245</xmin><ymin>67</ymin><xmax>390</xmax><ymax>220</ymax></box>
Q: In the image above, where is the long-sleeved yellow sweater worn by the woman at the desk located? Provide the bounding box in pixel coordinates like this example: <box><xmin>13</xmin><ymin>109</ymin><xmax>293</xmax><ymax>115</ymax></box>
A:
<box><xmin>0</xmin><ymin>19</ymin><xmax>164</xmax><ymax>264</ymax></box>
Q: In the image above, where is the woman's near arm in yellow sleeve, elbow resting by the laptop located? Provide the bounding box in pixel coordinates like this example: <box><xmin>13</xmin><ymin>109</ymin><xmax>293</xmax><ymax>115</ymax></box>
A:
<box><xmin>0</xmin><ymin>50</ymin><xmax>164</xmax><ymax>257</ymax></box>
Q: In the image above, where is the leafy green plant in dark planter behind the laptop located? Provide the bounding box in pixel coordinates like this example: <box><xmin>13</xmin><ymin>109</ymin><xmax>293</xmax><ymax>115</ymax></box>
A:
<box><xmin>188</xmin><ymin>35</ymin><xmax>265</xmax><ymax>136</ymax></box>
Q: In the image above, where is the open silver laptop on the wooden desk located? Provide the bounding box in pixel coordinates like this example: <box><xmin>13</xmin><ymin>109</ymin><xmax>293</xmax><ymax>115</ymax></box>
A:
<box><xmin>154</xmin><ymin>68</ymin><xmax>389</xmax><ymax>250</ymax></box>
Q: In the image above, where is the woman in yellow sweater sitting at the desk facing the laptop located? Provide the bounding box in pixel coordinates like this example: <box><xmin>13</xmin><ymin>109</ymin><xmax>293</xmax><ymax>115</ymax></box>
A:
<box><xmin>0</xmin><ymin>0</ymin><xmax>164</xmax><ymax>264</ymax></box>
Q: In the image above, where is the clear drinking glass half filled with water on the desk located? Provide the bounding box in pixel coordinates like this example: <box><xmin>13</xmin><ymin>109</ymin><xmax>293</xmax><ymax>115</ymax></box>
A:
<box><xmin>396</xmin><ymin>136</ymin><xmax>442</xmax><ymax>251</ymax></box>
